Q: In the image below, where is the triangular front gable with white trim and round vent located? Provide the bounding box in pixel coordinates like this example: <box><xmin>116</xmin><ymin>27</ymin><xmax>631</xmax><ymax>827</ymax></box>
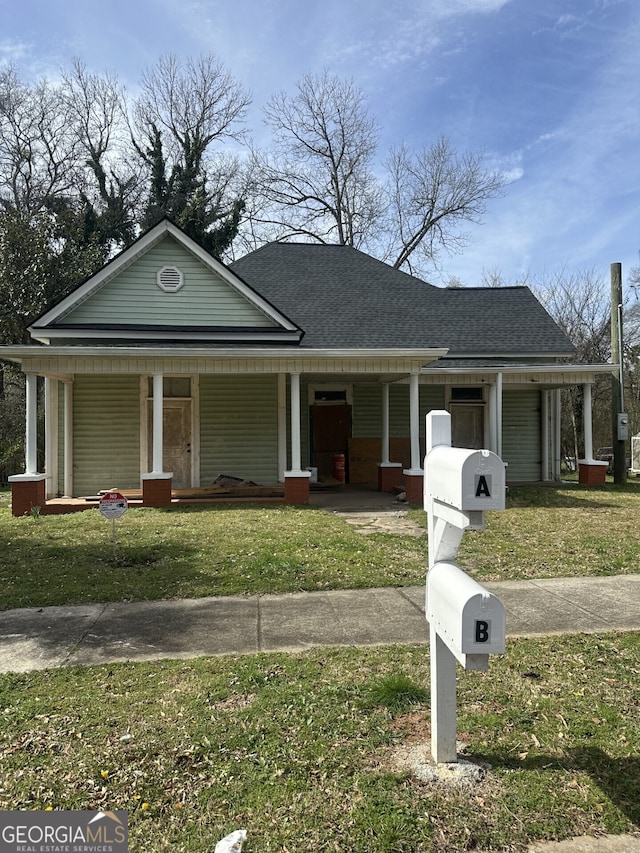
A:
<box><xmin>30</xmin><ymin>220</ymin><xmax>302</xmax><ymax>344</ymax></box>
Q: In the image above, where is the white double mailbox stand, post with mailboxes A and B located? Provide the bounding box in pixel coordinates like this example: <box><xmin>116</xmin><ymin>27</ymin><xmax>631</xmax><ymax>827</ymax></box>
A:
<box><xmin>424</xmin><ymin>411</ymin><xmax>506</xmax><ymax>764</ymax></box>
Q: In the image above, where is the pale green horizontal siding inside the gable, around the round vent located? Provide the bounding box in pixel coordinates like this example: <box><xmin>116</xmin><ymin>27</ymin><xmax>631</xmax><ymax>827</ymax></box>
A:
<box><xmin>63</xmin><ymin>237</ymin><xmax>275</xmax><ymax>327</ymax></box>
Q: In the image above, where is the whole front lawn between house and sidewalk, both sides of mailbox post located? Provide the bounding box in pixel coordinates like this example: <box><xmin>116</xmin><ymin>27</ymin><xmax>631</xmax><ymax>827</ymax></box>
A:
<box><xmin>0</xmin><ymin>480</ymin><xmax>640</xmax><ymax>609</ymax></box>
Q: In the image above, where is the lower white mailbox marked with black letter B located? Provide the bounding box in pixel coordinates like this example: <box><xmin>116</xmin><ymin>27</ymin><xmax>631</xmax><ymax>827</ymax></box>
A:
<box><xmin>427</xmin><ymin>561</ymin><xmax>506</xmax><ymax>669</ymax></box>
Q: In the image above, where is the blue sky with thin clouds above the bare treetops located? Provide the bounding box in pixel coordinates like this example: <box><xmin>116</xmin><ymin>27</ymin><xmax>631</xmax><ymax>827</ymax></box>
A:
<box><xmin>0</xmin><ymin>0</ymin><xmax>640</xmax><ymax>285</ymax></box>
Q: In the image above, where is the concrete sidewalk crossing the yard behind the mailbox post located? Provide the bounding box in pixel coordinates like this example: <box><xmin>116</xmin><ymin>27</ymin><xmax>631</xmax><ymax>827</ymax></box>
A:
<box><xmin>0</xmin><ymin>575</ymin><xmax>640</xmax><ymax>672</ymax></box>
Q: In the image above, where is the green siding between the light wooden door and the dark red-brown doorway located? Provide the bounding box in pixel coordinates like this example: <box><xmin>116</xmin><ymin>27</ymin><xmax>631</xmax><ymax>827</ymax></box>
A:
<box><xmin>200</xmin><ymin>376</ymin><xmax>278</xmax><ymax>486</ymax></box>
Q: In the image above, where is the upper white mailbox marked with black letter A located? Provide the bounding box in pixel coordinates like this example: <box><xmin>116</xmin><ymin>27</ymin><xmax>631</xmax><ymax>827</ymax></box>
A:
<box><xmin>424</xmin><ymin>445</ymin><xmax>506</xmax><ymax>512</ymax></box>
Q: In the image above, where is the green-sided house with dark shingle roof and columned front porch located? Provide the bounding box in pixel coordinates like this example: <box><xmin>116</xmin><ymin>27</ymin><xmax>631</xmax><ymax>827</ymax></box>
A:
<box><xmin>0</xmin><ymin>220</ymin><xmax>611</xmax><ymax>515</ymax></box>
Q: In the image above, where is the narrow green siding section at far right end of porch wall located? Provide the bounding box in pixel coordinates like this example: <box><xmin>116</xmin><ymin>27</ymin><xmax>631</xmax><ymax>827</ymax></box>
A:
<box><xmin>502</xmin><ymin>389</ymin><xmax>542</xmax><ymax>482</ymax></box>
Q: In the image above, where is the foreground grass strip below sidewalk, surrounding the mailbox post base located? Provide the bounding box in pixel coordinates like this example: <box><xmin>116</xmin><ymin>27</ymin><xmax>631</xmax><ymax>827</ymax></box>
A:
<box><xmin>0</xmin><ymin>633</ymin><xmax>640</xmax><ymax>853</ymax></box>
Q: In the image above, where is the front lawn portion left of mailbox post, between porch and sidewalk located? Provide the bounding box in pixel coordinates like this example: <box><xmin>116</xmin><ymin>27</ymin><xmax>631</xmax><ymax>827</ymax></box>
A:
<box><xmin>0</xmin><ymin>502</ymin><xmax>426</xmax><ymax>608</ymax></box>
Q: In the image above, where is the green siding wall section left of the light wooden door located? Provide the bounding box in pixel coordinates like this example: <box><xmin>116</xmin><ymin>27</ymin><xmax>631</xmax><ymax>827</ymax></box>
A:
<box><xmin>73</xmin><ymin>374</ymin><xmax>140</xmax><ymax>495</ymax></box>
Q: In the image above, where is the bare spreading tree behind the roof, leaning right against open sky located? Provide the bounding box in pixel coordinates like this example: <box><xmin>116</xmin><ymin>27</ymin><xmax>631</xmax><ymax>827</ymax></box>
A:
<box><xmin>386</xmin><ymin>136</ymin><xmax>505</xmax><ymax>271</ymax></box>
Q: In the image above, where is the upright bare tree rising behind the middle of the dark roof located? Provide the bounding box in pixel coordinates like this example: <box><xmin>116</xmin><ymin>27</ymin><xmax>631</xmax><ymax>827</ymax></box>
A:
<box><xmin>253</xmin><ymin>71</ymin><xmax>383</xmax><ymax>246</ymax></box>
